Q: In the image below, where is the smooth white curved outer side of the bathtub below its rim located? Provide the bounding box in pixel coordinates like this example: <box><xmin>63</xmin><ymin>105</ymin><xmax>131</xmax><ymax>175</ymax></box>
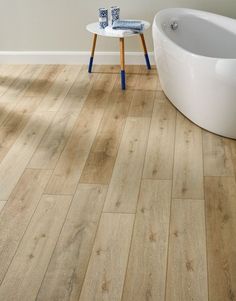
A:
<box><xmin>153</xmin><ymin>9</ymin><xmax>236</xmax><ymax>139</ymax></box>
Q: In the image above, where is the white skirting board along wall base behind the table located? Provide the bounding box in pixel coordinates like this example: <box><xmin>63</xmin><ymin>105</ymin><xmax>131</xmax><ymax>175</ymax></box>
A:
<box><xmin>0</xmin><ymin>51</ymin><xmax>154</xmax><ymax>65</ymax></box>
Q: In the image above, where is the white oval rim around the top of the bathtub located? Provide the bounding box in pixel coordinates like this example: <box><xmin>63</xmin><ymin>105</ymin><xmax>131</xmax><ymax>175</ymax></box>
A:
<box><xmin>152</xmin><ymin>7</ymin><xmax>236</xmax><ymax>61</ymax></box>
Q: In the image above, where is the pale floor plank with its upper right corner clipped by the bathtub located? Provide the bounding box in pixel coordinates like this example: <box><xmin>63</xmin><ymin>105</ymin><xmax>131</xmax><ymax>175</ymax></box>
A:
<box><xmin>143</xmin><ymin>94</ymin><xmax>176</xmax><ymax>180</ymax></box>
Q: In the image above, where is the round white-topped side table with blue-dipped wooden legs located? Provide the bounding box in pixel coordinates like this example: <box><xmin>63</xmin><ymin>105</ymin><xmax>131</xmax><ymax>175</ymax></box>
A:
<box><xmin>86</xmin><ymin>21</ymin><xmax>151</xmax><ymax>90</ymax></box>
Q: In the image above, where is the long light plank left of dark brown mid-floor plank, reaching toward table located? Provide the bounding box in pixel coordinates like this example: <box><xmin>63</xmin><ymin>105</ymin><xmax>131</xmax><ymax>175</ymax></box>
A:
<box><xmin>46</xmin><ymin>74</ymin><xmax>117</xmax><ymax>194</ymax></box>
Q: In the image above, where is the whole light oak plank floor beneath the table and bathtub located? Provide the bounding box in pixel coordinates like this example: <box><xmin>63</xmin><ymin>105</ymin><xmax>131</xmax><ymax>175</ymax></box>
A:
<box><xmin>0</xmin><ymin>65</ymin><xmax>236</xmax><ymax>301</ymax></box>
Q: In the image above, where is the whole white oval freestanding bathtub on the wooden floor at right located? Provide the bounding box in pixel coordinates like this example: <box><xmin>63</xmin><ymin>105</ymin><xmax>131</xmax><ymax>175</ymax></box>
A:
<box><xmin>153</xmin><ymin>8</ymin><xmax>236</xmax><ymax>139</ymax></box>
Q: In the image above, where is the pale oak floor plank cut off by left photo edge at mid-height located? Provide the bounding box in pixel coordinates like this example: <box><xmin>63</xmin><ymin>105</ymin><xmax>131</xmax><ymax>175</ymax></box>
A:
<box><xmin>0</xmin><ymin>112</ymin><xmax>53</xmax><ymax>200</ymax></box>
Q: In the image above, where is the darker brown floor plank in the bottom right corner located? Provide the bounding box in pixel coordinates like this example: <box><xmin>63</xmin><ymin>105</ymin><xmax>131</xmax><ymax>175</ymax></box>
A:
<box><xmin>205</xmin><ymin>177</ymin><xmax>236</xmax><ymax>301</ymax></box>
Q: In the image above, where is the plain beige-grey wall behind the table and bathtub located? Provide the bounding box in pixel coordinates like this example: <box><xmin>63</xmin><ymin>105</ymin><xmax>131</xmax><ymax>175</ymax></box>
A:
<box><xmin>0</xmin><ymin>0</ymin><xmax>236</xmax><ymax>51</ymax></box>
